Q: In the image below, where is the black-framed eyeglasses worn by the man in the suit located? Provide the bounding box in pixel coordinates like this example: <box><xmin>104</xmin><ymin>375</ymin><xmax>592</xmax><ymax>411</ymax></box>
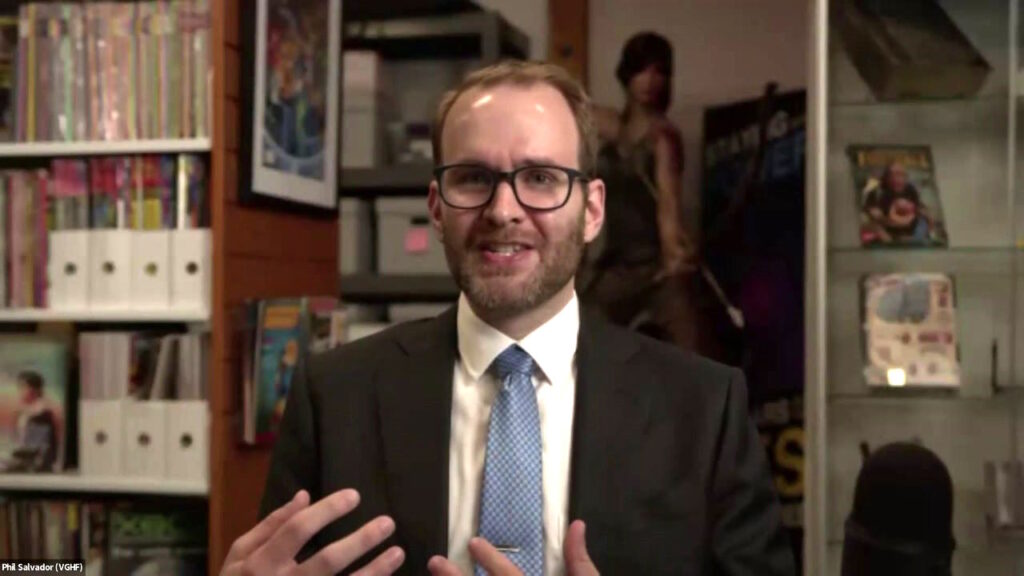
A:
<box><xmin>434</xmin><ymin>164</ymin><xmax>589</xmax><ymax>210</ymax></box>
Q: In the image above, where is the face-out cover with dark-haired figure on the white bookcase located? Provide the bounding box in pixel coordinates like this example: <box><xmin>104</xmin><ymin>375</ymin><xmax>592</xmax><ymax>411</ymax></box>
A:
<box><xmin>0</xmin><ymin>336</ymin><xmax>69</xmax><ymax>471</ymax></box>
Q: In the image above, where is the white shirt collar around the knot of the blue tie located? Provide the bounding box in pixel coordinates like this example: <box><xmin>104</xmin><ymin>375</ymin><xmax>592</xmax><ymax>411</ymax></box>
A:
<box><xmin>457</xmin><ymin>292</ymin><xmax>580</xmax><ymax>384</ymax></box>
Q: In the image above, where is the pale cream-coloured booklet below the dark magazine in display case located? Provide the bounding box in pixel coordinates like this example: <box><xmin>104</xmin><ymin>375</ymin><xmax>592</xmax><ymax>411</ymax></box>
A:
<box><xmin>861</xmin><ymin>274</ymin><xmax>961</xmax><ymax>387</ymax></box>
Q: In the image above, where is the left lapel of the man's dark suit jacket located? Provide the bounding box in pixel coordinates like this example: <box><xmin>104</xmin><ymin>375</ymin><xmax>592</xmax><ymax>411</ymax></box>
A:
<box><xmin>378</xmin><ymin>307</ymin><xmax>457</xmax><ymax>566</ymax></box>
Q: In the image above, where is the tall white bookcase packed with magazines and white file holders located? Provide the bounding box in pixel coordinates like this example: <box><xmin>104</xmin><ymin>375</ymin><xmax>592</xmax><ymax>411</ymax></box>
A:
<box><xmin>0</xmin><ymin>0</ymin><xmax>228</xmax><ymax>574</ymax></box>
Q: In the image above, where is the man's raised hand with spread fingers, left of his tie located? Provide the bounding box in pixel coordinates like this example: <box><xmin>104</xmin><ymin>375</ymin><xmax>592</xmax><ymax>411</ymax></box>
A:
<box><xmin>220</xmin><ymin>490</ymin><xmax>406</xmax><ymax>576</ymax></box>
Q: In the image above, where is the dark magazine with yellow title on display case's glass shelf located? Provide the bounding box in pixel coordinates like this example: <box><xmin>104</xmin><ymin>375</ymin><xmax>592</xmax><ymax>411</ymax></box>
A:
<box><xmin>847</xmin><ymin>145</ymin><xmax>948</xmax><ymax>247</ymax></box>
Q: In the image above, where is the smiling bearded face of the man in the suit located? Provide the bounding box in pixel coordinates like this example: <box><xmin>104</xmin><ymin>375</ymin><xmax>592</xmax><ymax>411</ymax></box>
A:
<box><xmin>428</xmin><ymin>84</ymin><xmax>604</xmax><ymax>316</ymax></box>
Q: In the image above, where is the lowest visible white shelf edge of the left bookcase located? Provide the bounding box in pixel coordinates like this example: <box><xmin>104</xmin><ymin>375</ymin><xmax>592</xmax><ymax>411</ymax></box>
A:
<box><xmin>0</xmin><ymin>471</ymin><xmax>209</xmax><ymax>496</ymax></box>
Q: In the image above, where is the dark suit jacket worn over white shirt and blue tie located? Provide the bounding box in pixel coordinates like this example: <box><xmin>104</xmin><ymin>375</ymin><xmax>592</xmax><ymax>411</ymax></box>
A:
<box><xmin>260</xmin><ymin>307</ymin><xmax>795</xmax><ymax>576</ymax></box>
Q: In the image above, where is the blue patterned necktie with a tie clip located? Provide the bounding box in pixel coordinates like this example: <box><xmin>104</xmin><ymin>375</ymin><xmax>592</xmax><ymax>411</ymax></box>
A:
<box><xmin>476</xmin><ymin>344</ymin><xmax>544</xmax><ymax>576</ymax></box>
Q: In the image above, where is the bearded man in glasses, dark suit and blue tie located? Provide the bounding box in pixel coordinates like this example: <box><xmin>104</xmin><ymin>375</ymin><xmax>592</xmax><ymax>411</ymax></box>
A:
<box><xmin>224</xmin><ymin>63</ymin><xmax>793</xmax><ymax>576</ymax></box>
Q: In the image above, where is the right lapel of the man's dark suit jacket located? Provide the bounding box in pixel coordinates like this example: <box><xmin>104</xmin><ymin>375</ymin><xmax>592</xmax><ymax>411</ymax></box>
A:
<box><xmin>569</xmin><ymin>315</ymin><xmax>650</xmax><ymax>521</ymax></box>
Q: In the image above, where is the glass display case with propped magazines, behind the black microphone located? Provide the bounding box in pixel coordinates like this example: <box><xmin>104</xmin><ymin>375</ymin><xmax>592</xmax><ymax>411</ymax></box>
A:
<box><xmin>804</xmin><ymin>0</ymin><xmax>1024</xmax><ymax>576</ymax></box>
